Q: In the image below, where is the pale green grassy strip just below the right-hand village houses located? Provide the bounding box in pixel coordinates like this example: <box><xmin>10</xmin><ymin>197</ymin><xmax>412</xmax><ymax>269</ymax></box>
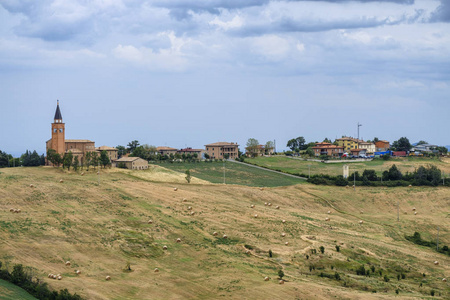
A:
<box><xmin>245</xmin><ymin>156</ymin><xmax>450</xmax><ymax>177</ymax></box>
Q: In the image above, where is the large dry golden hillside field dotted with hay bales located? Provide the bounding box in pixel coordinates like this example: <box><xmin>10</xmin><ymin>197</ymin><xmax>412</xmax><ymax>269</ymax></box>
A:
<box><xmin>0</xmin><ymin>167</ymin><xmax>450</xmax><ymax>299</ymax></box>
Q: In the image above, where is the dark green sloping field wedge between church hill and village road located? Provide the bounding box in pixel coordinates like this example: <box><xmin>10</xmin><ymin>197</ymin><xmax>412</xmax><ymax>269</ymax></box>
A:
<box><xmin>152</xmin><ymin>162</ymin><xmax>305</xmax><ymax>187</ymax></box>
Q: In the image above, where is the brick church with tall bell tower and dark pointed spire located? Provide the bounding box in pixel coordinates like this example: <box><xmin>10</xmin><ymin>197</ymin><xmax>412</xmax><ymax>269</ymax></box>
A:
<box><xmin>46</xmin><ymin>100</ymin><xmax>118</xmax><ymax>165</ymax></box>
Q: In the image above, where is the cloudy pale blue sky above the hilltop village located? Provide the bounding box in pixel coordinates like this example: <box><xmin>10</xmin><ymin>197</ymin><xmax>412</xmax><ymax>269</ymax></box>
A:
<box><xmin>0</xmin><ymin>0</ymin><xmax>450</xmax><ymax>155</ymax></box>
